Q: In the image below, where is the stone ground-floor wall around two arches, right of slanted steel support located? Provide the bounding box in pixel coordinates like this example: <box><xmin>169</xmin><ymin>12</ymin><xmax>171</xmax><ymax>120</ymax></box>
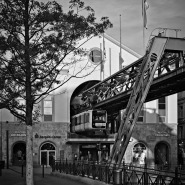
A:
<box><xmin>125</xmin><ymin>123</ymin><xmax>177</xmax><ymax>166</ymax></box>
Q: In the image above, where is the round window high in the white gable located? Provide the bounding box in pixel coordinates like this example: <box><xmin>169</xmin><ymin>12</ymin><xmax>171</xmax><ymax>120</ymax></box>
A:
<box><xmin>89</xmin><ymin>48</ymin><xmax>102</xmax><ymax>64</ymax></box>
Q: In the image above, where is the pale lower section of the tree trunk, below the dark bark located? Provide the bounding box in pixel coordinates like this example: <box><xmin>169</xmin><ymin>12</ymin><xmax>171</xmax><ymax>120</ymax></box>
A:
<box><xmin>26</xmin><ymin>125</ymin><xmax>34</xmax><ymax>185</ymax></box>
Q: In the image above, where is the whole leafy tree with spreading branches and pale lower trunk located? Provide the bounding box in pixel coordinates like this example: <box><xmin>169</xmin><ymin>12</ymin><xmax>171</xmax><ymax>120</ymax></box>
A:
<box><xmin>0</xmin><ymin>0</ymin><xmax>112</xmax><ymax>185</ymax></box>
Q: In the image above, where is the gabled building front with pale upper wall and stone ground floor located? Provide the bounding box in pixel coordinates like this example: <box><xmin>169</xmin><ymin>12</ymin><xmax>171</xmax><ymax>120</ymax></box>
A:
<box><xmin>0</xmin><ymin>35</ymin><xmax>177</xmax><ymax>166</ymax></box>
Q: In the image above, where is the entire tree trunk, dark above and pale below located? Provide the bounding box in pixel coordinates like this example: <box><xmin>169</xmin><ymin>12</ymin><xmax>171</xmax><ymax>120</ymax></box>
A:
<box><xmin>24</xmin><ymin>0</ymin><xmax>34</xmax><ymax>185</ymax></box>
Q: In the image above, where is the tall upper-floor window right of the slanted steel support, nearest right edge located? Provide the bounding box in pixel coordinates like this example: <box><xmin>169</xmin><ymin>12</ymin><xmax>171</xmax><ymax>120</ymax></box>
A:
<box><xmin>158</xmin><ymin>97</ymin><xmax>166</xmax><ymax>123</ymax></box>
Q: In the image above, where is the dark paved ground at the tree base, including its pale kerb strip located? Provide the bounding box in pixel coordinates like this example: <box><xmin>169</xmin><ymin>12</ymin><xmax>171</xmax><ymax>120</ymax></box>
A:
<box><xmin>0</xmin><ymin>166</ymin><xmax>105</xmax><ymax>185</ymax></box>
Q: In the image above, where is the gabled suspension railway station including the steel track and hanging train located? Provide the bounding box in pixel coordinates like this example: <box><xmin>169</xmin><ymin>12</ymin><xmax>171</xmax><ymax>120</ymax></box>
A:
<box><xmin>1</xmin><ymin>28</ymin><xmax>185</xmax><ymax>175</ymax></box>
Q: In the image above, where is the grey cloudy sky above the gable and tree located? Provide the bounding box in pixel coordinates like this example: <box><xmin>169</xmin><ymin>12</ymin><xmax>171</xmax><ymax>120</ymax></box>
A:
<box><xmin>42</xmin><ymin>0</ymin><xmax>185</xmax><ymax>55</ymax></box>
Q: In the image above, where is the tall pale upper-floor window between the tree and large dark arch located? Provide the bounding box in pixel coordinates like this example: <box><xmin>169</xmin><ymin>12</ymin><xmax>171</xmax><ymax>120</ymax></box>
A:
<box><xmin>43</xmin><ymin>96</ymin><xmax>53</xmax><ymax>121</ymax></box>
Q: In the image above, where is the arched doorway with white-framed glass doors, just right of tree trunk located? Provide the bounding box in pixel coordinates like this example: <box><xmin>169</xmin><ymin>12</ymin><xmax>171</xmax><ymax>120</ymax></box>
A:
<box><xmin>40</xmin><ymin>143</ymin><xmax>56</xmax><ymax>166</ymax></box>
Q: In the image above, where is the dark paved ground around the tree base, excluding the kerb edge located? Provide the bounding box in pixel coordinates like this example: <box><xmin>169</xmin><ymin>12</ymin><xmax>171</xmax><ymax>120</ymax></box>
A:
<box><xmin>0</xmin><ymin>167</ymin><xmax>87</xmax><ymax>185</ymax></box>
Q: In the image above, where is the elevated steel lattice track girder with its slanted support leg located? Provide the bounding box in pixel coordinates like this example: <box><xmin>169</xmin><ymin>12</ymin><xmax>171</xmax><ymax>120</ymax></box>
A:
<box><xmin>73</xmin><ymin>31</ymin><xmax>185</xmax><ymax>167</ymax></box>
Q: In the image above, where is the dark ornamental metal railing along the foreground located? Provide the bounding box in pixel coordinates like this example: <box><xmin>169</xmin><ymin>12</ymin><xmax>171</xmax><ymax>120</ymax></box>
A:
<box><xmin>52</xmin><ymin>160</ymin><xmax>185</xmax><ymax>185</ymax></box>
